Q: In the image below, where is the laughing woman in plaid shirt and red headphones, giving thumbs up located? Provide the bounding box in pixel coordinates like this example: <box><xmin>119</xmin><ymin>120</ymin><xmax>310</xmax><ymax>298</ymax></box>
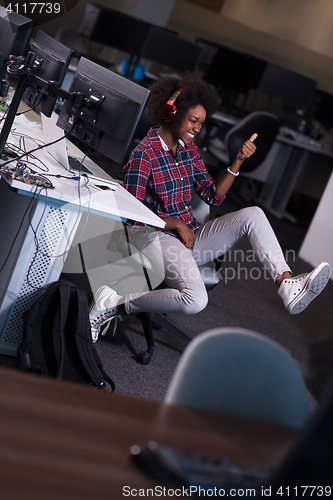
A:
<box><xmin>90</xmin><ymin>75</ymin><xmax>330</xmax><ymax>341</ymax></box>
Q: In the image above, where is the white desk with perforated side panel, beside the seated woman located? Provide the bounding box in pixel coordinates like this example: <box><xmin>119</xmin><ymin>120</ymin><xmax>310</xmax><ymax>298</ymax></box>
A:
<box><xmin>0</xmin><ymin>109</ymin><xmax>165</xmax><ymax>356</ymax></box>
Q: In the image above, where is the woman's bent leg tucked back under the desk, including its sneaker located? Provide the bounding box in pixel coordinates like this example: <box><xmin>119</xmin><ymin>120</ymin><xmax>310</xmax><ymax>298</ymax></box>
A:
<box><xmin>89</xmin><ymin>231</ymin><xmax>208</xmax><ymax>342</ymax></box>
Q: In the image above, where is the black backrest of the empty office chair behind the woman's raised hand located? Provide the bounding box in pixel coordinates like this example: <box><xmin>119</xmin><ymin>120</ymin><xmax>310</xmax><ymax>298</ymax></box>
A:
<box><xmin>224</xmin><ymin>111</ymin><xmax>280</xmax><ymax>172</ymax></box>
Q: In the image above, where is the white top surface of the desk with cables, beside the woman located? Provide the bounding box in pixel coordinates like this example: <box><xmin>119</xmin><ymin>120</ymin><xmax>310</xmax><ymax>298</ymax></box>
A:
<box><xmin>0</xmin><ymin>112</ymin><xmax>165</xmax><ymax>228</ymax></box>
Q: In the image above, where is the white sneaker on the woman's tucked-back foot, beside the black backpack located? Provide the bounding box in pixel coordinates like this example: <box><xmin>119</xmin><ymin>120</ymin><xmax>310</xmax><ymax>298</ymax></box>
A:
<box><xmin>89</xmin><ymin>286</ymin><xmax>122</xmax><ymax>342</ymax></box>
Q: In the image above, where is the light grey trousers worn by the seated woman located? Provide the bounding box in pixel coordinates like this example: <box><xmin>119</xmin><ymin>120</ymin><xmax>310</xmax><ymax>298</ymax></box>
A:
<box><xmin>124</xmin><ymin>207</ymin><xmax>291</xmax><ymax>314</ymax></box>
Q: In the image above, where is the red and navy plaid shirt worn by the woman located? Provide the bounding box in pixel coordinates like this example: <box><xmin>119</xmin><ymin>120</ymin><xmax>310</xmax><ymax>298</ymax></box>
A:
<box><xmin>123</xmin><ymin>128</ymin><xmax>224</xmax><ymax>236</ymax></box>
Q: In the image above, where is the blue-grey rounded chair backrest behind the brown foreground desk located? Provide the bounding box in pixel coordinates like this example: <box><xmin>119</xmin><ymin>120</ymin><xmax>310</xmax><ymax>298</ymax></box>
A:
<box><xmin>165</xmin><ymin>328</ymin><xmax>309</xmax><ymax>427</ymax></box>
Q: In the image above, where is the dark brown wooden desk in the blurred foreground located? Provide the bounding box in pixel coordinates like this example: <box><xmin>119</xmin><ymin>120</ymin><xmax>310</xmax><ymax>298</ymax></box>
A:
<box><xmin>0</xmin><ymin>368</ymin><xmax>298</xmax><ymax>500</ymax></box>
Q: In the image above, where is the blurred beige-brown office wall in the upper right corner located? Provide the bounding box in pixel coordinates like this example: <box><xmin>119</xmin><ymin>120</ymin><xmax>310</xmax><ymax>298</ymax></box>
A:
<box><xmin>169</xmin><ymin>0</ymin><xmax>333</xmax><ymax>93</ymax></box>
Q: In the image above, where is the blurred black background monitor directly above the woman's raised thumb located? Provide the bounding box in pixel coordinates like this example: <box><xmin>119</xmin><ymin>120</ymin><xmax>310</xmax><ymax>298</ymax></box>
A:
<box><xmin>206</xmin><ymin>46</ymin><xmax>264</xmax><ymax>94</ymax></box>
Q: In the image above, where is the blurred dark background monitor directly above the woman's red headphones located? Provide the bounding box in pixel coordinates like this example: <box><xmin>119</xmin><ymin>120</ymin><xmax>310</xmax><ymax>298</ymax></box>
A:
<box><xmin>140</xmin><ymin>26</ymin><xmax>202</xmax><ymax>73</ymax></box>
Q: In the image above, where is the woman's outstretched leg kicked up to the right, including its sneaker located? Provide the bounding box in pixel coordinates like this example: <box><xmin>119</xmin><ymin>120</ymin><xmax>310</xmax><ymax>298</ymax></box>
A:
<box><xmin>193</xmin><ymin>207</ymin><xmax>331</xmax><ymax>314</ymax></box>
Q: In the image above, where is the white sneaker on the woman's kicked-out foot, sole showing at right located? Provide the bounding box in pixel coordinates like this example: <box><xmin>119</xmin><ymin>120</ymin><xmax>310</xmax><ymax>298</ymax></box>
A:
<box><xmin>278</xmin><ymin>262</ymin><xmax>331</xmax><ymax>314</ymax></box>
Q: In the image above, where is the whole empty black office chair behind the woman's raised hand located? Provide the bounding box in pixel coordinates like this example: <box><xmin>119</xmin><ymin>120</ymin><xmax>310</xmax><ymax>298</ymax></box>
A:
<box><xmin>207</xmin><ymin>111</ymin><xmax>279</xmax><ymax>206</ymax></box>
